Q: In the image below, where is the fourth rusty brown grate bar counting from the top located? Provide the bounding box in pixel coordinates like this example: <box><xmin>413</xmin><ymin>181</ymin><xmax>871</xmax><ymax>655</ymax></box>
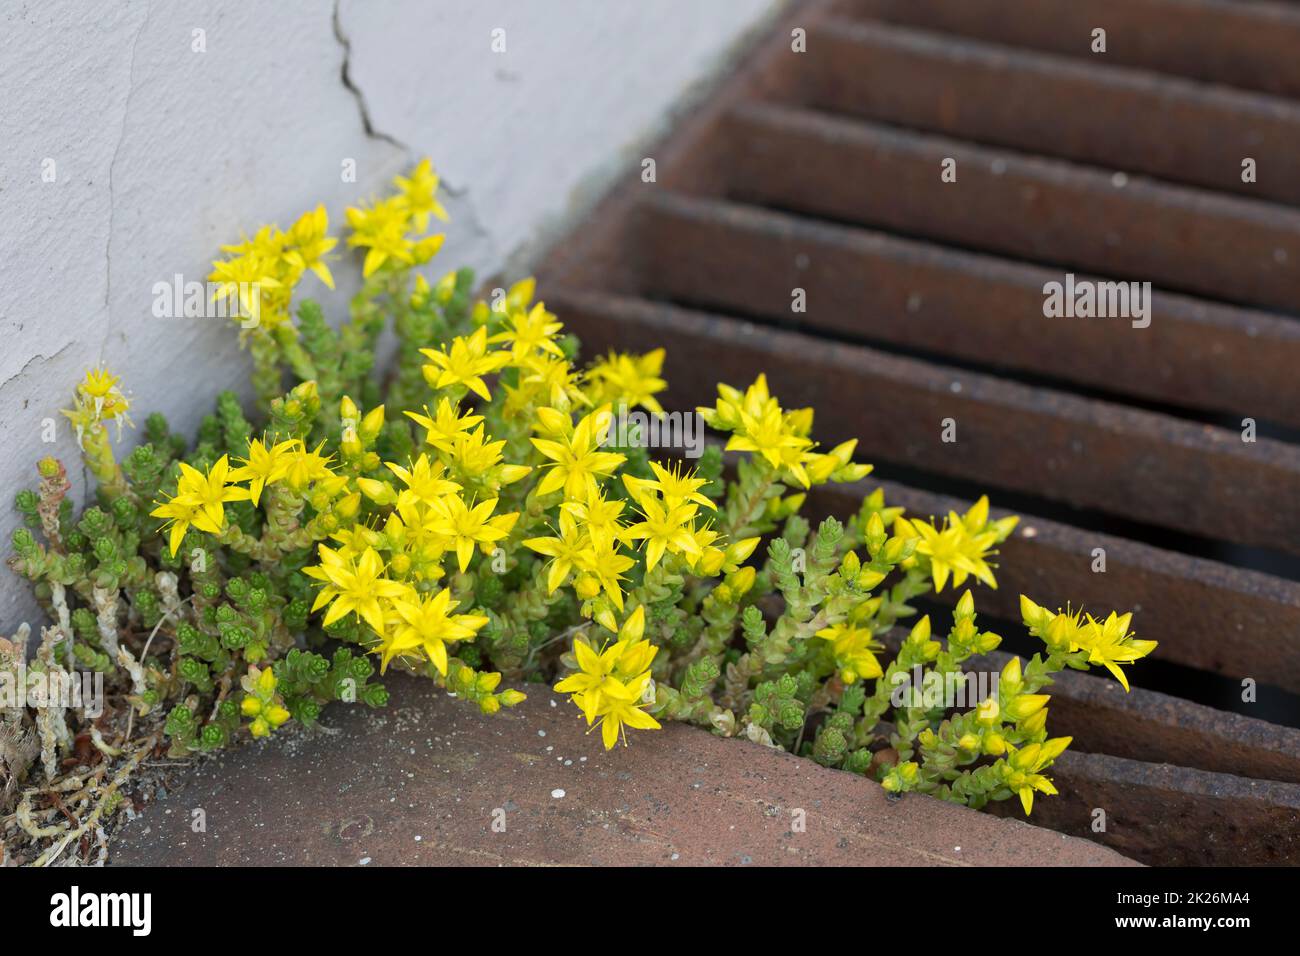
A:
<box><xmin>637</xmin><ymin>193</ymin><xmax>1300</xmax><ymax>425</ymax></box>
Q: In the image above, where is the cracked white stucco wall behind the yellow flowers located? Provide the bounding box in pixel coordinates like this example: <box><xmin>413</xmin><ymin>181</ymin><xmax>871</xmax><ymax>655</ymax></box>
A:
<box><xmin>0</xmin><ymin>0</ymin><xmax>780</xmax><ymax>633</ymax></box>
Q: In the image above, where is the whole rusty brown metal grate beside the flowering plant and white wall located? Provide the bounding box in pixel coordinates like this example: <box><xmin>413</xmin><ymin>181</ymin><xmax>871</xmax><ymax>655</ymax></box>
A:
<box><xmin>541</xmin><ymin>0</ymin><xmax>1300</xmax><ymax>864</ymax></box>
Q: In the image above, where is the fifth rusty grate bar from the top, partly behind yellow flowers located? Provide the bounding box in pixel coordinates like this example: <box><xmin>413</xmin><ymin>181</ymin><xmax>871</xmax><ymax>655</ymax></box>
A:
<box><xmin>547</xmin><ymin>287</ymin><xmax>1300</xmax><ymax>551</ymax></box>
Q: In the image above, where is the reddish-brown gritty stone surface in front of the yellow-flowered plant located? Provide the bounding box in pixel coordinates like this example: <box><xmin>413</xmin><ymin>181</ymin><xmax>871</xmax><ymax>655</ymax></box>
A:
<box><xmin>112</xmin><ymin>678</ymin><xmax>1132</xmax><ymax>866</ymax></box>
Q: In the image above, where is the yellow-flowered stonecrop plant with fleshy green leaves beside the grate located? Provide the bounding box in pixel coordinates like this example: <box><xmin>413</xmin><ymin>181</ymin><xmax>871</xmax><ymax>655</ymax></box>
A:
<box><xmin>0</xmin><ymin>160</ymin><xmax>1154</xmax><ymax>853</ymax></box>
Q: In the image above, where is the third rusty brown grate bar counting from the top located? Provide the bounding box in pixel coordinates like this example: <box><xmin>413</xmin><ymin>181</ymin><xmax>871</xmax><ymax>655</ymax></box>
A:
<box><xmin>723</xmin><ymin>104</ymin><xmax>1300</xmax><ymax>315</ymax></box>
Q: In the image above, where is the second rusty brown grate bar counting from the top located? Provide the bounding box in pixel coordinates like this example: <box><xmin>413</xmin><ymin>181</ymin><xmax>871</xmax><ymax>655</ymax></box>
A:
<box><xmin>803</xmin><ymin>18</ymin><xmax>1300</xmax><ymax>203</ymax></box>
